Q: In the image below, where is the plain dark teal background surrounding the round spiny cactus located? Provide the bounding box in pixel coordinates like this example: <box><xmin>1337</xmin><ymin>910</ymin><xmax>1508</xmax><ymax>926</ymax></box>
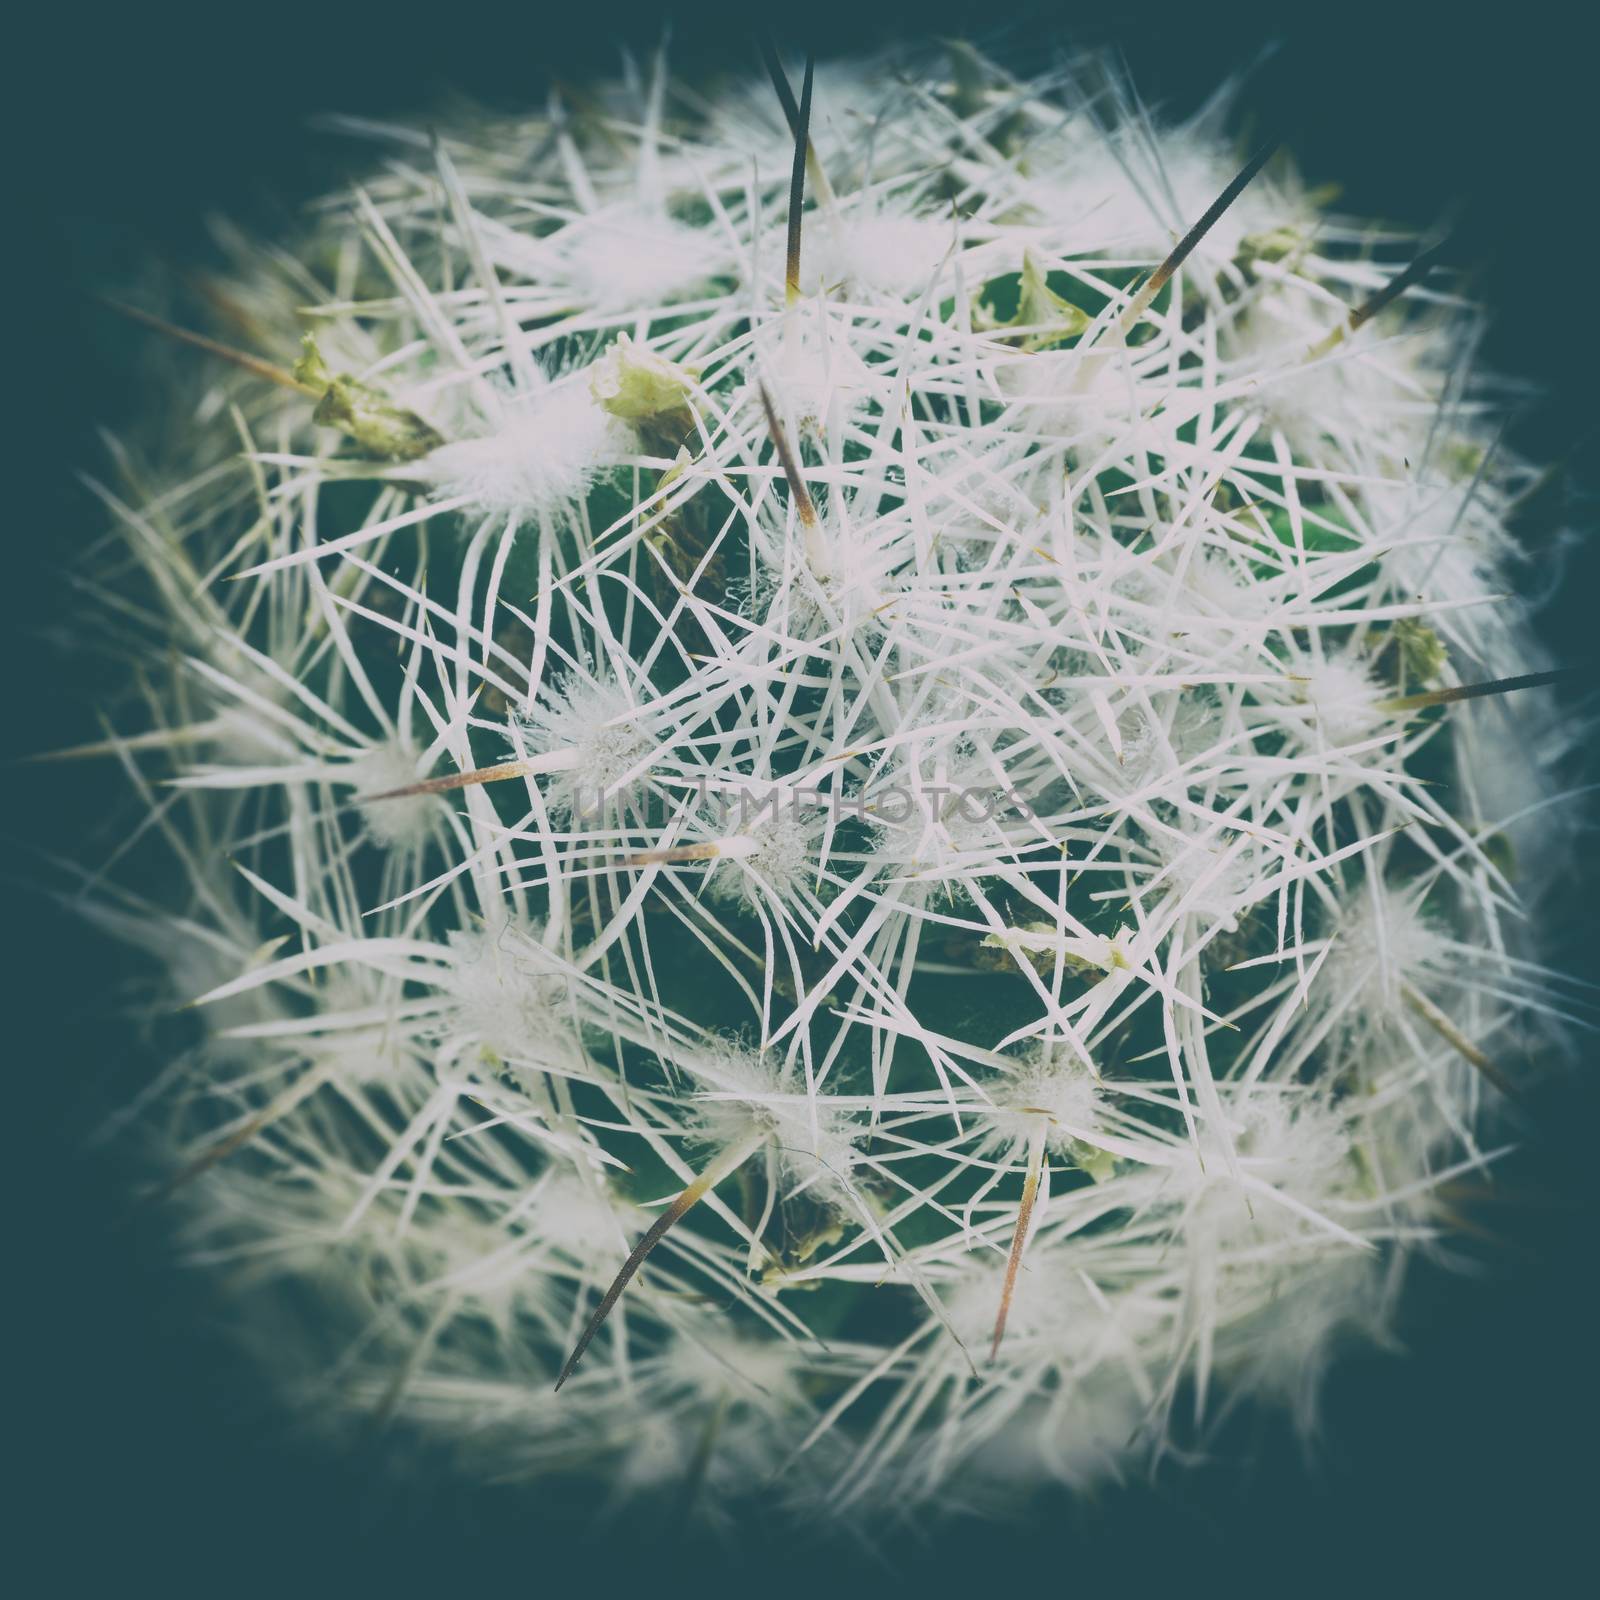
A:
<box><xmin>15</xmin><ymin>0</ymin><xmax>1600</xmax><ymax>1600</ymax></box>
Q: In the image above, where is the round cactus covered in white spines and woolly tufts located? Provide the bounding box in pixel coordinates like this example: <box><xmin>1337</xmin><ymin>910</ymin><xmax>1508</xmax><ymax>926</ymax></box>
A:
<box><xmin>68</xmin><ymin>46</ymin><xmax>1571</xmax><ymax>1517</ymax></box>
